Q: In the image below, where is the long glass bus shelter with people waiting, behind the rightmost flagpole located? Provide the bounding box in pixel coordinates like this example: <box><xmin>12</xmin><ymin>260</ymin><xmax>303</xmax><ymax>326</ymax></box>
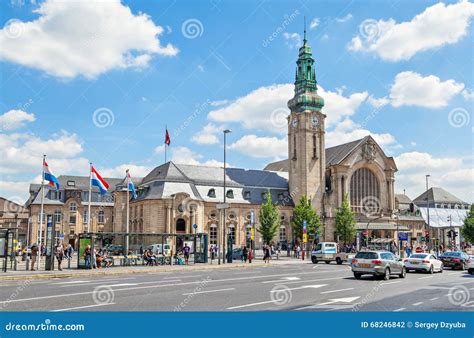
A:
<box><xmin>77</xmin><ymin>232</ymin><xmax>208</xmax><ymax>269</ymax></box>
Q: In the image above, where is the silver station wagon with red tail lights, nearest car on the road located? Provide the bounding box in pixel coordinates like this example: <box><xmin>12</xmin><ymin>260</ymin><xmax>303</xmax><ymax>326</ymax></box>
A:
<box><xmin>351</xmin><ymin>250</ymin><xmax>406</xmax><ymax>280</ymax></box>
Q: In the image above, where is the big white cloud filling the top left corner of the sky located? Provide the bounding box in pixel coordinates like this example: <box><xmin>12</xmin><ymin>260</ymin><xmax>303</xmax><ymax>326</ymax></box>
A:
<box><xmin>0</xmin><ymin>0</ymin><xmax>178</xmax><ymax>78</ymax></box>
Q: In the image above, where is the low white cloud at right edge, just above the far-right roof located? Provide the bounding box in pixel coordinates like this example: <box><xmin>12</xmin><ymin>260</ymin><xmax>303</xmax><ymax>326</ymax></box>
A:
<box><xmin>395</xmin><ymin>151</ymin><xmax>474</xmax><ymax>203</ymax></box>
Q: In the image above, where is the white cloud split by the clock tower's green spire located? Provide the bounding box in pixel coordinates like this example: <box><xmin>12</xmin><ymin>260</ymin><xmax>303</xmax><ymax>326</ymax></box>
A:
<box><xmin>208</xmin><ymin>83</ymin><xmax>368</xmax><ymax>134</ymax></box>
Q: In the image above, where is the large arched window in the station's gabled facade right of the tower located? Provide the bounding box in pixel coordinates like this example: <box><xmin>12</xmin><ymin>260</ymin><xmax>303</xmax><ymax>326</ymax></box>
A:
<box><xmin>350</xmin><ymin>168</ymin><xmax>380</xmax><ymax>214</ymax></box>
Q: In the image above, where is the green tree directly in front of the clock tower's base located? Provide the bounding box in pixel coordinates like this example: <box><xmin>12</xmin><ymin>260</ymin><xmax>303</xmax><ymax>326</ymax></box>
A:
<box><xmin>291</xmin><ymin>195</ymin><xmax>321</xmax><ymax>238</ymax></box>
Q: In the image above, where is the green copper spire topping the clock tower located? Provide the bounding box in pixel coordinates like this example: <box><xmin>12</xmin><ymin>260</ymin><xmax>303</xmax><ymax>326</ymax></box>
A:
<box><xmin>288</xmin><ymin>23</ymin><xmax>324</xmax><ymax>111</ymax></box>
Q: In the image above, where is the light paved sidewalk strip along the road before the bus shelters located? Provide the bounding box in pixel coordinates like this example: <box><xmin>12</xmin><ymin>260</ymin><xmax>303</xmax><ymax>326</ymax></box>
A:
<box><xmin>0</xmin><ymin>256</ymin><xmax>311</xmax><ymax>281</ymax></box>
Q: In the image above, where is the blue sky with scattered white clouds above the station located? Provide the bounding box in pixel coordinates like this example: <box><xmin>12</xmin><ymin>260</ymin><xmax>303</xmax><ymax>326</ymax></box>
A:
<box><xmin>0</xmin><ymin>0</ymin><xmax>474</xmax><ymax>202</ymax></box>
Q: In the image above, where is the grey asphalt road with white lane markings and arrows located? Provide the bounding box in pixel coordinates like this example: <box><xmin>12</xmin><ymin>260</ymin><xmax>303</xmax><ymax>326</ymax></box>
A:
<box><xmin>0</xmin><ymin>262</ymin><xmax>474</xmax><ymax>311</ymax></box>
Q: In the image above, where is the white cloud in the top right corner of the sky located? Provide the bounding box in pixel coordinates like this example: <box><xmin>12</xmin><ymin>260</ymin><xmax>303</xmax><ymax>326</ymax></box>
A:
<box><xmin>349</xmin><ymin>1</ymin><xmax>474</xmax><ymax>61</ymax></box>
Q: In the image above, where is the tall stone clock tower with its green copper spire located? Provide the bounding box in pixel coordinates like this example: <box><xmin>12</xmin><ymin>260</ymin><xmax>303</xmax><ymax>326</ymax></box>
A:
<box><xmin>288</xmin><ymin>28</ymin><xmax>326</xmax><ymax>212</ymax></box>
